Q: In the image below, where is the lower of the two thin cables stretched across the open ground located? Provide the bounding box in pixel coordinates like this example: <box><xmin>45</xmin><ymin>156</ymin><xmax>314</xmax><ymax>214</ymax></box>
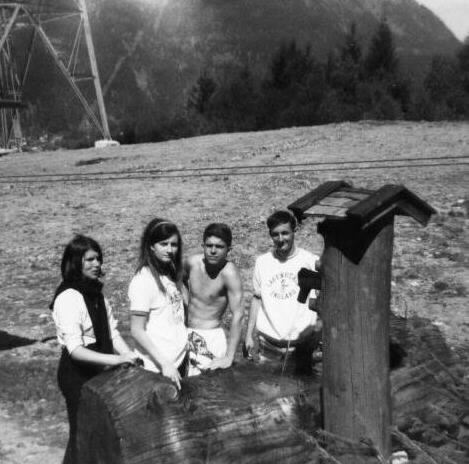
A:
<box><xmin>0</xmin><ymin>161</ymin><xmax>469</xmax><ymax>185</ymax></box>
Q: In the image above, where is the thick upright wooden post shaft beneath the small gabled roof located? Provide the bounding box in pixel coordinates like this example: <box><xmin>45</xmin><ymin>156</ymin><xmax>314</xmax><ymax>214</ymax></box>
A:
<box><xmin>318</xmin><ymin>215</ymin><xmax>394</xmax><ymax>463</ymax></box>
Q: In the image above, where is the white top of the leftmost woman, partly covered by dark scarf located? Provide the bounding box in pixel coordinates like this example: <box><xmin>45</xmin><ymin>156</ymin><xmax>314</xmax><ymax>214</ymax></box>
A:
<box><xmin>52</xmin><ymin>288</ymin><xmax>119</xmax><ymax>353</ymax></box>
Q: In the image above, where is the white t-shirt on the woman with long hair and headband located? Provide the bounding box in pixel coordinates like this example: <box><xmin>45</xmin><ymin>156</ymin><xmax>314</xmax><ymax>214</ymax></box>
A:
<box><xmin>128</xmin><ymin>267</ymin><xmax>187</xmax><ymax>372</ymax></box>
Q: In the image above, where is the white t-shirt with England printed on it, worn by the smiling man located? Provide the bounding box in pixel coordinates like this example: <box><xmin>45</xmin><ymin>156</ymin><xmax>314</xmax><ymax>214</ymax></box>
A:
<box><xmin>253</xmin><ymin>248</ymin><xmax>319</xmax><ymax>340</ymax></box>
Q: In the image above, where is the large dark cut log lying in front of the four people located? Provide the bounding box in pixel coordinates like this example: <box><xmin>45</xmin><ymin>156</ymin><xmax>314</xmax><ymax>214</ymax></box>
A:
<box><xmin>78</xmin><ymin>362</ymin><xmax>320</xmax><ymax>464</ymax></box>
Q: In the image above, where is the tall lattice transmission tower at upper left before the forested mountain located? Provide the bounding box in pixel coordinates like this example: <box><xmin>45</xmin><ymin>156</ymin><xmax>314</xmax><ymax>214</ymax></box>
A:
<box><xmin>0</xmin><ymin>0</ymin><xmax>111</xmax><ymax>148</ymax></box>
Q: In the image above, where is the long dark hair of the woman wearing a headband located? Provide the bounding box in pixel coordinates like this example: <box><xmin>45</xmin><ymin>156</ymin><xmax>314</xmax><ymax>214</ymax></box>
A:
<box><xmin>136</xmin><ymin>218</ymin><xmax>182</xmax><ymax>293</ymax></box>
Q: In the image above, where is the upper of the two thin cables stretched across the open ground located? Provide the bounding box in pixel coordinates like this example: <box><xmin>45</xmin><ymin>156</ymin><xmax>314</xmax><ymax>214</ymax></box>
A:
<box><xmin>0</xmin><ymin>155</ymin><xmax>469</xmax><ymax>180</ymax></box>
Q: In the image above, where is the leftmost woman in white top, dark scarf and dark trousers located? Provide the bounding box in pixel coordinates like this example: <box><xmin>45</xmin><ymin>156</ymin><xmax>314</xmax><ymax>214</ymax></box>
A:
<box><xmin>51</xmin><ymin>235</ymin><xmax>138</xmax><ymax>464</ymax></box>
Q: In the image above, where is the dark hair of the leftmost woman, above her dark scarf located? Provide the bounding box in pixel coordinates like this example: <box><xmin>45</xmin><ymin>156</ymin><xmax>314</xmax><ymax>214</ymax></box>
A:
<box><xmin>60</xmin><ymin>235</ymin><xmax>103</xmax><ymax>282</ymax></box>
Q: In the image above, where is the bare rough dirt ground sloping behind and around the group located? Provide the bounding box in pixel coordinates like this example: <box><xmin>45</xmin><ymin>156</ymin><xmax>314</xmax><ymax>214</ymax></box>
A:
<box><xmin>0</xmin><ymin>122</ymin><xmax>469</xmax><ymax>464</ymax></box>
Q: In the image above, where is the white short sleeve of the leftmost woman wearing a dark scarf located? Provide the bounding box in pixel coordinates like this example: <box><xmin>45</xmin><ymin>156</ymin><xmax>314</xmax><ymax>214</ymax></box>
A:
<box><xmin>52</xmin><ymin>290</ymin><xmax>87</xmax><ymax>354</ymax></box>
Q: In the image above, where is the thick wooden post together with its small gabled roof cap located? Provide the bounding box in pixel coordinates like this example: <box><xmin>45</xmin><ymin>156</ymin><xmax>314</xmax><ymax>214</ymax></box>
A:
<box><xmin>288</xmin><ymin>181</ymin><xmax>435</xmax><ymax>463</ymax></box>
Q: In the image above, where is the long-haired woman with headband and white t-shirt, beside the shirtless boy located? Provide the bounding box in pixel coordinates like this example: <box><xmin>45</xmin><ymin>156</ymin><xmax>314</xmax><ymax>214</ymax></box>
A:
<box><xmin>128</xmin><ymin>218</ymin><xmax>187</xmax><ymax>388</ymax></box>
